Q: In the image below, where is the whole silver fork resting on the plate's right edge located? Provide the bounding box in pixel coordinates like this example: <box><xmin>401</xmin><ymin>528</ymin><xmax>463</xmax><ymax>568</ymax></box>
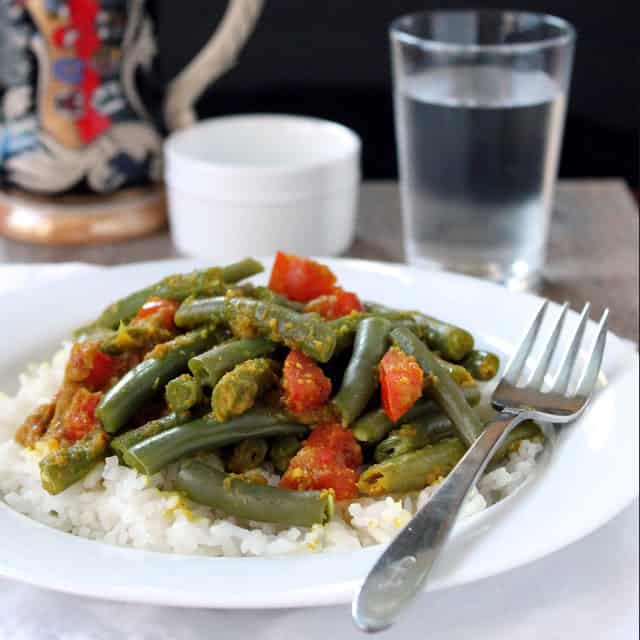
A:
<box><xmin>352</xmin><ymin>302</ymin><xmax>609</xmax><ymax>631</ymax></box>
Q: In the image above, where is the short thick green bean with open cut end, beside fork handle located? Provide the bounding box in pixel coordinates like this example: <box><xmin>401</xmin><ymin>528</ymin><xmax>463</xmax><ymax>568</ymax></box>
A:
<box><xmin>358</xmin><ymin>438</ymin><xmax>465</xmax><ymax>496</ymax></box>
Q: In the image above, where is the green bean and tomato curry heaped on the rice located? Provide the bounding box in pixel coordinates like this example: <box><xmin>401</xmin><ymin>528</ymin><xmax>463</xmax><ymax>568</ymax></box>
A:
<box><xmin>16</xmin><ymin>252</ymin><xmax>540</xmax><ymax>526</ymax></box>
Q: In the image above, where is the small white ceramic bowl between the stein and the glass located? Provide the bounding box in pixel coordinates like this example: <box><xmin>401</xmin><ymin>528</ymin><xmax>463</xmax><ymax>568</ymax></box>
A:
<box><xmin>165</xmin><ymin>115</ymin><xmax>360</xmax><ymax>260</ymax></box>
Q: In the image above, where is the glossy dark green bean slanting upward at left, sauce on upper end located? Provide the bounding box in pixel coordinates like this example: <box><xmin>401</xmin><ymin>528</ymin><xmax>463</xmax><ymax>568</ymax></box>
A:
<box><xmin>96</xmin><ymin>329</ymin><xmax>218</xmax><ymax>433</ymax></box>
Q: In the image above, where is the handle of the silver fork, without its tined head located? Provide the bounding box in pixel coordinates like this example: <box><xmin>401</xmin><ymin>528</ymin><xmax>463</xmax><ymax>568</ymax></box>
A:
<box><xmin>352</xmin><ymin>414</ymin><xmax>527</xmax><ymax>631</ymax></box>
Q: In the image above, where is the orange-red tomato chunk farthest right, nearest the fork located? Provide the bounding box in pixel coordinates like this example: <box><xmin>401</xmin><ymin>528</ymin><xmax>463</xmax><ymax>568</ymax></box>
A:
<box><xmin>380</xmin><ymin>347</ymin><xmax>424</xmax><ymax>422</ymax></box>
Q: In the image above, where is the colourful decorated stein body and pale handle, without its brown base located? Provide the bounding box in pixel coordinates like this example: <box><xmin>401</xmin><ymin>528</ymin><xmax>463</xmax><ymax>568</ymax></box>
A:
<box><xmin>0</xmin><ymin>0</ymin><xmax>262</xmax><ymax>241</ymax></box>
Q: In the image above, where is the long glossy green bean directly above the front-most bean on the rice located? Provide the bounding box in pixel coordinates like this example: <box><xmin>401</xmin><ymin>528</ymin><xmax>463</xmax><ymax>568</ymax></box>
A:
<box><xmin>123</xmin><ymin>409</ymin><xmax>308</xmax><ymax>475</ymax></box>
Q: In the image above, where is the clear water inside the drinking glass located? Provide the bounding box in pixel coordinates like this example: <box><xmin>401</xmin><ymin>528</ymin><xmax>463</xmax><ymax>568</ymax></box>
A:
<box><xmin>395</xmin><ymin>64</ymin><xmax>565</xmax><ymax>288</ymax></box>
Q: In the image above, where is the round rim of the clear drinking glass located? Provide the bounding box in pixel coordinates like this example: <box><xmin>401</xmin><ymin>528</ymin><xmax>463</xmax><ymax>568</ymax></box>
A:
<box><xmin>389</xmin><ymin>9</ymin><xmax>576</xmax><ymax>54</ymax></box>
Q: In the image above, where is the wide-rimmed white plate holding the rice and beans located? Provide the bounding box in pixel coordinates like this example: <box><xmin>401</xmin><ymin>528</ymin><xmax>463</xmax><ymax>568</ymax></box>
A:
<box><xmin>0</xmin><ymin>260</ymin><xmax>638</xmax><ymax>608</ymax></box>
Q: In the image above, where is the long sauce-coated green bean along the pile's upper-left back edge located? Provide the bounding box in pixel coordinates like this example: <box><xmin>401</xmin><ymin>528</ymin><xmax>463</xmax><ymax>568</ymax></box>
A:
<box><xmin>76</xmin><ymin>258</ymin><xmax>263</xmax><ymax>334</ymax></box>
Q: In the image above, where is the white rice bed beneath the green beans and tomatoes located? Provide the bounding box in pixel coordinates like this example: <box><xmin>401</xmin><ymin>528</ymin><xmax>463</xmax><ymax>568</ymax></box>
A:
<box><xmin>0</xmin><ymin>345</ymin><xmax>542</xmax><ymax>556</ymax></box>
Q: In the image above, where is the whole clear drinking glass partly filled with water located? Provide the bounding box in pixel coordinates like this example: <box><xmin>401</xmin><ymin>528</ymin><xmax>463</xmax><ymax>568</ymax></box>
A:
<box><xmin>390</xmin><ymin>10</ymin><xmax>575</xmax><ymax>289</ymax></box>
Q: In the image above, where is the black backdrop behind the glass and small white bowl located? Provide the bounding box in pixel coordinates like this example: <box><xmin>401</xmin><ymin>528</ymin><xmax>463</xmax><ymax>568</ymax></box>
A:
<box><xmin>152</xmin><ymin>0</ymin><xmax>640</xmax><ymax>188</ymax></box>
